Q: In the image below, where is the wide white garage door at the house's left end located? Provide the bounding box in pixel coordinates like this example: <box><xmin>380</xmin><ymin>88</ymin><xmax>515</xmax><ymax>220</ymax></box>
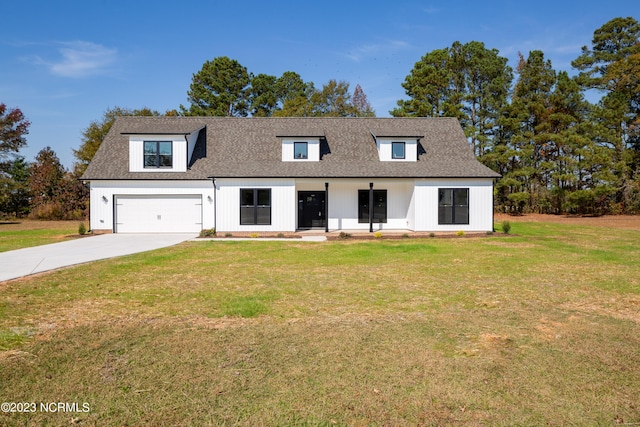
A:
<box><xmin>115</xmin><ymin>195</ymin><xmax>202</xmax><ymax>233</ymax></box>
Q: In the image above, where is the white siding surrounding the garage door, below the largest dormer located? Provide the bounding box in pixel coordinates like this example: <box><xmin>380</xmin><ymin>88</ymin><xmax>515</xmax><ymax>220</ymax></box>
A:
<box><xmin>90</xmin><ymin>180</ymin><xmax>215</xmax><ymax>231</ymax></box>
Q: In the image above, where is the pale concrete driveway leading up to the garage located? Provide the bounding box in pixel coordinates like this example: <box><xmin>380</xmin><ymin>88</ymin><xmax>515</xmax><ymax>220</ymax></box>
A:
<box><xmin>0</xmin><ymin>233</ymin><xmax>197</xmax><ymax>282</ymax></box>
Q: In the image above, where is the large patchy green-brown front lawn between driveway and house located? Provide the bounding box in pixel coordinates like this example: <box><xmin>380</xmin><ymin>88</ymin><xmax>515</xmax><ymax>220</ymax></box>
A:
<box><xmin>0</xmin><ymin>222</ymin><xmax>640</xmax><ymax>426</ymax></box>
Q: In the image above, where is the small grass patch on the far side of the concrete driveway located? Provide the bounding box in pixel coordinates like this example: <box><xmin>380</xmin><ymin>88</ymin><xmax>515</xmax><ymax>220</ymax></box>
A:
<box><xmin>0</xmin><ymin>220</ymin><xmax>80</xmax><ymax>252</ymax></box>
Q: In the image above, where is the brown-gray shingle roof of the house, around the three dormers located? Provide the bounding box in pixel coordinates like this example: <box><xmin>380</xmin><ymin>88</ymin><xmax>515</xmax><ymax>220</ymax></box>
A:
<box><xmin>83</xmin><ymin>117</ymin><xmax>500</xmax><ymax>180</ymax></box>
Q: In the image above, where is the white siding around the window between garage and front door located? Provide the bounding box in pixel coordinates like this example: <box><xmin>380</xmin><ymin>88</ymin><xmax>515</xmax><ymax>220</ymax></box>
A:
<box><xmin>215</xmin><ymin>178</ymin><xmax>297</xmax><ymax>232</ymax></box>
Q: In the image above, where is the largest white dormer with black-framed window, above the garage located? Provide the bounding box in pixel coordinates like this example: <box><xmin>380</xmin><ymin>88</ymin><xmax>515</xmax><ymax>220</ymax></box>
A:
<box><xmin>123</xmin><ymin>128</ymin><xmax>204</xmax><ymax>173</ymax></box>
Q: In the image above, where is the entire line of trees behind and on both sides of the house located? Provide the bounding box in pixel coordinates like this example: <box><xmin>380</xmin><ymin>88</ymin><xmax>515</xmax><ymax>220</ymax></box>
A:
<box><xmin>0</xmin><ymin>17</ymin><xmax>640</xmax><ymax>219</ymax></box>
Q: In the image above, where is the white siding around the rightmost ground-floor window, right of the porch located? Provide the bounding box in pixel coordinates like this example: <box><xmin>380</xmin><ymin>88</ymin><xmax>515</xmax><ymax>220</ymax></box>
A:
<box><xmin>415</xmin><ymin>178</ymin><xmax>493</xmax><ymax>231</ymax></box>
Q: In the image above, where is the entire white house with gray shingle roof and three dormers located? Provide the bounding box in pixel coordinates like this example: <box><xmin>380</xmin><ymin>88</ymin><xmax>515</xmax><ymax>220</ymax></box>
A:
<box><xmin>82</xmin><ymin>117</ymin><xmax>500</xmax><ymax>233</ymax></box>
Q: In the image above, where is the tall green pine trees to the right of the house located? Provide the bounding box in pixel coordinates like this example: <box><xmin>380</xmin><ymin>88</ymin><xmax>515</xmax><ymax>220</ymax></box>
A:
<box><xmin>391</xmin><ymin>17</ymin><xmax>640</xmax><ymax>214</ymax></box>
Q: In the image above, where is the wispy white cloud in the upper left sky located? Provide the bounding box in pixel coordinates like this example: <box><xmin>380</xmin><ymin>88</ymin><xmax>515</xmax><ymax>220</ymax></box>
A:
<box><xmin>35</xmin><ymin>41</ymin><xmax>118</xmax><ymax>78</ymax></box>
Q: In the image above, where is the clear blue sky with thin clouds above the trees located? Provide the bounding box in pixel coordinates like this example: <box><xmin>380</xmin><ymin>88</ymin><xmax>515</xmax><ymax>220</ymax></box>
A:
<box><xmin>0</xmin><ymin>0</ymin><xmax>640</xmax><ymax>168</ymax></box>
